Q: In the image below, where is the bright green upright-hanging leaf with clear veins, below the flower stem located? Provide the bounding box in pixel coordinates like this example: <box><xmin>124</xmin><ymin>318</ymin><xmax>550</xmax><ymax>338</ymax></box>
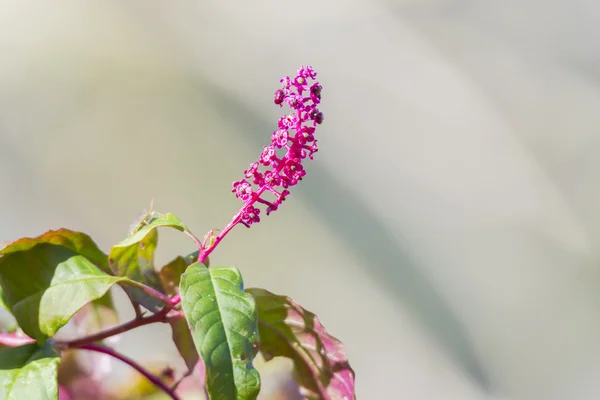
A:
<box><xmin>180</xmin><ymin>263</ymin><xmax>260</xmax><ymax>400</ymax></box>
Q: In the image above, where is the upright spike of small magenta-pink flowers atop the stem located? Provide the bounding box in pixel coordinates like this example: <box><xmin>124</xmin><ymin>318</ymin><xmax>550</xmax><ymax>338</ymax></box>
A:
<box><xmin>232</xmin><ymin>66</ymin><xmax>323</xmax><ymax>227</ymax></box>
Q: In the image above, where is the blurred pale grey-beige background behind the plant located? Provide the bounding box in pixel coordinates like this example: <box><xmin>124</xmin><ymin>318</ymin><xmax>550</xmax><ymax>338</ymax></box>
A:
<box><xmin>0</xmin><ymin>0</ymin><xmax>600</xmax><ymax>400</ymax></box>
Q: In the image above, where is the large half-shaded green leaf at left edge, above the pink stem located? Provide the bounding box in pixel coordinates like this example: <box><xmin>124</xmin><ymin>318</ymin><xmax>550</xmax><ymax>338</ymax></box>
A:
<box><xmin>0</xmin><ymin>243</ymin><xmax>126</xmax><ymax>344</ymax></box>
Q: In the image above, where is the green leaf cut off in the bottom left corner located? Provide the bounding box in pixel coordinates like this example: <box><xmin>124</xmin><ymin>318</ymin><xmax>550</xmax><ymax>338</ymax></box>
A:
<box><xmin>0</xmin><ymin>344</ymin><xmax>60</xmax><ymax>400</ymax></box>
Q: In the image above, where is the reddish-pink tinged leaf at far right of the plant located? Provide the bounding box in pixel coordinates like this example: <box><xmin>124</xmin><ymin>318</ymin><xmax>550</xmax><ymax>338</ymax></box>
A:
<box><xmin>246</xmin><ymin>289</ymin><xmax>356</xmax><ymax>400</ymax></box>
